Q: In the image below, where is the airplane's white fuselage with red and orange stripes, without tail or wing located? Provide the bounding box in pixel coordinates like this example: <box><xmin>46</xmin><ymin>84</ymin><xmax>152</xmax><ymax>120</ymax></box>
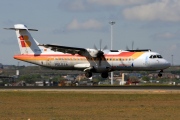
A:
<box><xmin>14</xmin><ymin>51</ymin><xmax>170</xmax><ymax>72</ymax></box>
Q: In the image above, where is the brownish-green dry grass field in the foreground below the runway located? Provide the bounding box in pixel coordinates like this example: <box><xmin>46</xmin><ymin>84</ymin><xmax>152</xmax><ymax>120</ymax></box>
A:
<box><xmin>0</xmin><ymin>91</ymin><xmax>180</xmax><ymax>120</ymax></box>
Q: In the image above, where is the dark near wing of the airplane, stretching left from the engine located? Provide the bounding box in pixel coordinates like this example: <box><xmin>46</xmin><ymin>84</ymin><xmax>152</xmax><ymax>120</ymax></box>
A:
<box><xmin>39</xmin><ymin>44</ymin><xmax>88</xmax><ymax>56</ymax></box>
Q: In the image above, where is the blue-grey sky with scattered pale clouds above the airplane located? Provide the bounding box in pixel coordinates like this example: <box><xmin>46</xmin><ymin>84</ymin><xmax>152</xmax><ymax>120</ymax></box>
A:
<box><xmin>0</xmin><ymin>0</ymin><xmax>180</xmax><ymax>65</ymax></box>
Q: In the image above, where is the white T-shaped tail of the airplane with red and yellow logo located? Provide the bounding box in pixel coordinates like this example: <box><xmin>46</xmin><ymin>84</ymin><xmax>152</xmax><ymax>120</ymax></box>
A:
<box><xmin>5</xmin><ymin>24</ymin><xmax>42</xmax><ymax>54</ymax></box>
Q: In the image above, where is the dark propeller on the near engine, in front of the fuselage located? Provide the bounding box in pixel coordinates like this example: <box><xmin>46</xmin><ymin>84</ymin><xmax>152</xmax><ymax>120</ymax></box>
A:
<box><xmin>94</xmin><ymin>39</ymin><xmax>107</xmax><ymax>66</ymax></box>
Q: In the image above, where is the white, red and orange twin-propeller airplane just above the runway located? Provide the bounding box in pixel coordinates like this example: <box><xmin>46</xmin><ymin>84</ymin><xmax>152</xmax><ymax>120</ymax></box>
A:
<box><xmin>4</xmin><ymin>24</ymin><xmax>170</xmax><ymax>78</ymax></box>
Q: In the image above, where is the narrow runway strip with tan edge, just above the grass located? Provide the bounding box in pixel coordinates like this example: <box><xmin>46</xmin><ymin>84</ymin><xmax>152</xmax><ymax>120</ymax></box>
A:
<box><xmin>0</xmin><ymin>86</ymin><xmax>180</xmax><ymax>93</ymax></box>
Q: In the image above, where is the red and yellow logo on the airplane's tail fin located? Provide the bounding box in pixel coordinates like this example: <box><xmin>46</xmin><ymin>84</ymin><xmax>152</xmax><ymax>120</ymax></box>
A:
<box><xmin>19</xmin><ymin>35</ymin><xmax>31</xmax><ymax>47</ymax></box>
